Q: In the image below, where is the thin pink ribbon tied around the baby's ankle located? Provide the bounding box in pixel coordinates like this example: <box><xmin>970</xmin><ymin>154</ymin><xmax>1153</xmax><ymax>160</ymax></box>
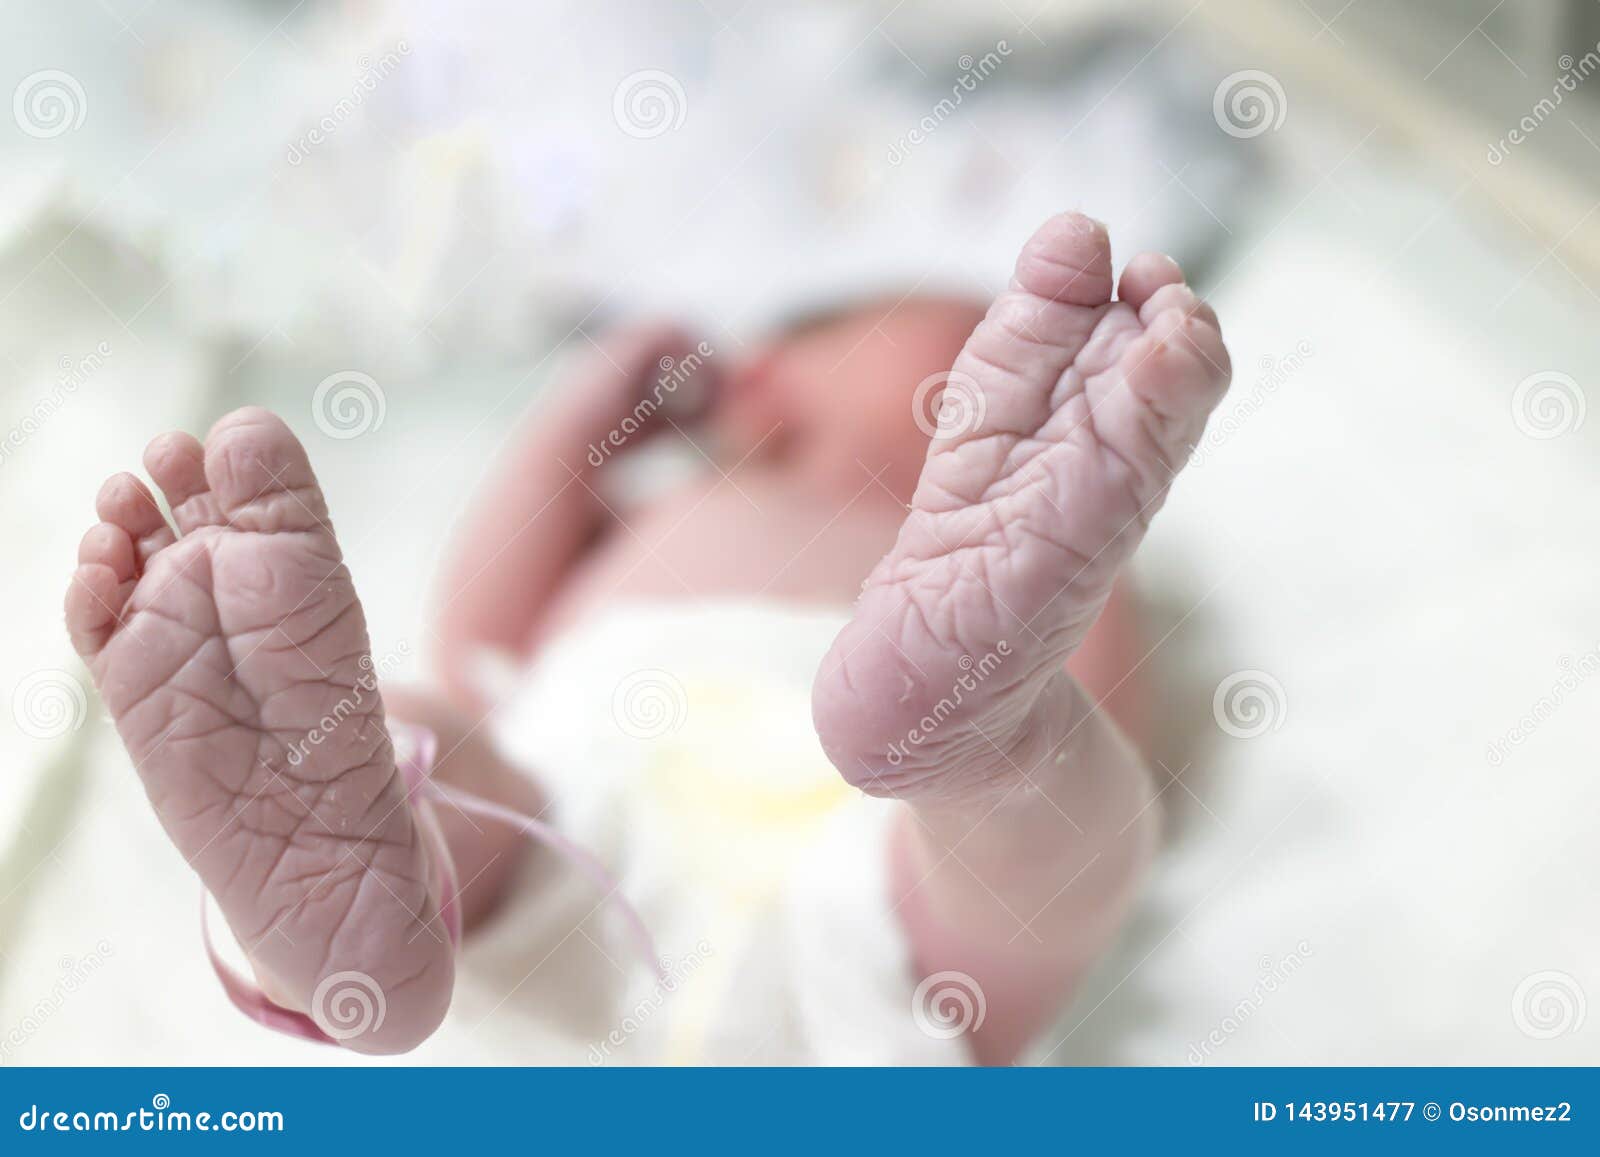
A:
<box><xmin>200</xmin><ymin>723</ymin><xmax>664</xmax><ymax>1045</ymax></box>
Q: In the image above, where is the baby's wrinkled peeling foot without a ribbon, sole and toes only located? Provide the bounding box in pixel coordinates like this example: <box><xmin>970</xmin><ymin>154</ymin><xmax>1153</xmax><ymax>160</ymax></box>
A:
<box><xmin>813</xmin><ymin>213</ymin><xmax>1229</xmax><ymax>797</ymax></box>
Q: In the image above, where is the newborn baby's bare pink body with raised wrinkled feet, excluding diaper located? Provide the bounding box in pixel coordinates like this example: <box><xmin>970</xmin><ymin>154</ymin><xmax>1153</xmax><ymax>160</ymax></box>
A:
<box><xmin>66</xmin><ymin>213</ymin><xmax>1229</xmax><ymax>1064</ymax></box>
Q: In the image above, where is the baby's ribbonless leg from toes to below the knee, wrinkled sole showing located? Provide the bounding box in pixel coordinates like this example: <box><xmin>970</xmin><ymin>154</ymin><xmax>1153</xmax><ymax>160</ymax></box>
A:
<box><xmin>813</xmin><ymin>214</ymin><xmax>1229</xmax><ymax>1063</ymax></box>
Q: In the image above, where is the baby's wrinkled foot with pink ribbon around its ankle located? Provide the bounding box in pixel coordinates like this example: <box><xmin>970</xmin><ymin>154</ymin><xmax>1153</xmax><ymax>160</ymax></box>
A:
<box><xmin>67</xmin><ymin>408</ymin><xmax>454</xmax><ymax>1053</ymax></box>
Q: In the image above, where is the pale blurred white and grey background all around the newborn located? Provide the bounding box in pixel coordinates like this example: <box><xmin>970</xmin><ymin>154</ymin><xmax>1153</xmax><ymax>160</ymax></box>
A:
<box><xmin>0</xmin><ymin>0</ymin><xmax>1600</xmax><ymax>1064</ymax></box>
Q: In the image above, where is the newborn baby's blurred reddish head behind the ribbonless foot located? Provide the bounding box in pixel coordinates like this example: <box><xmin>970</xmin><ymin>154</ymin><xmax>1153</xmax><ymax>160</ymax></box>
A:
<box><xmin>712</xmin><ymin>296</ymin><xmax>984</xmax><ymax>501</ymax></box>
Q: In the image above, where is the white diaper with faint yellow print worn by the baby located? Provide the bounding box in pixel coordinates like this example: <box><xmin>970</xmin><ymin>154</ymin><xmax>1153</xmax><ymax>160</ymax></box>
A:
<box><xmin>429</xmin><ymin>602</ymin><xmax>965</xmax><ymax>1064</ymax></box>
